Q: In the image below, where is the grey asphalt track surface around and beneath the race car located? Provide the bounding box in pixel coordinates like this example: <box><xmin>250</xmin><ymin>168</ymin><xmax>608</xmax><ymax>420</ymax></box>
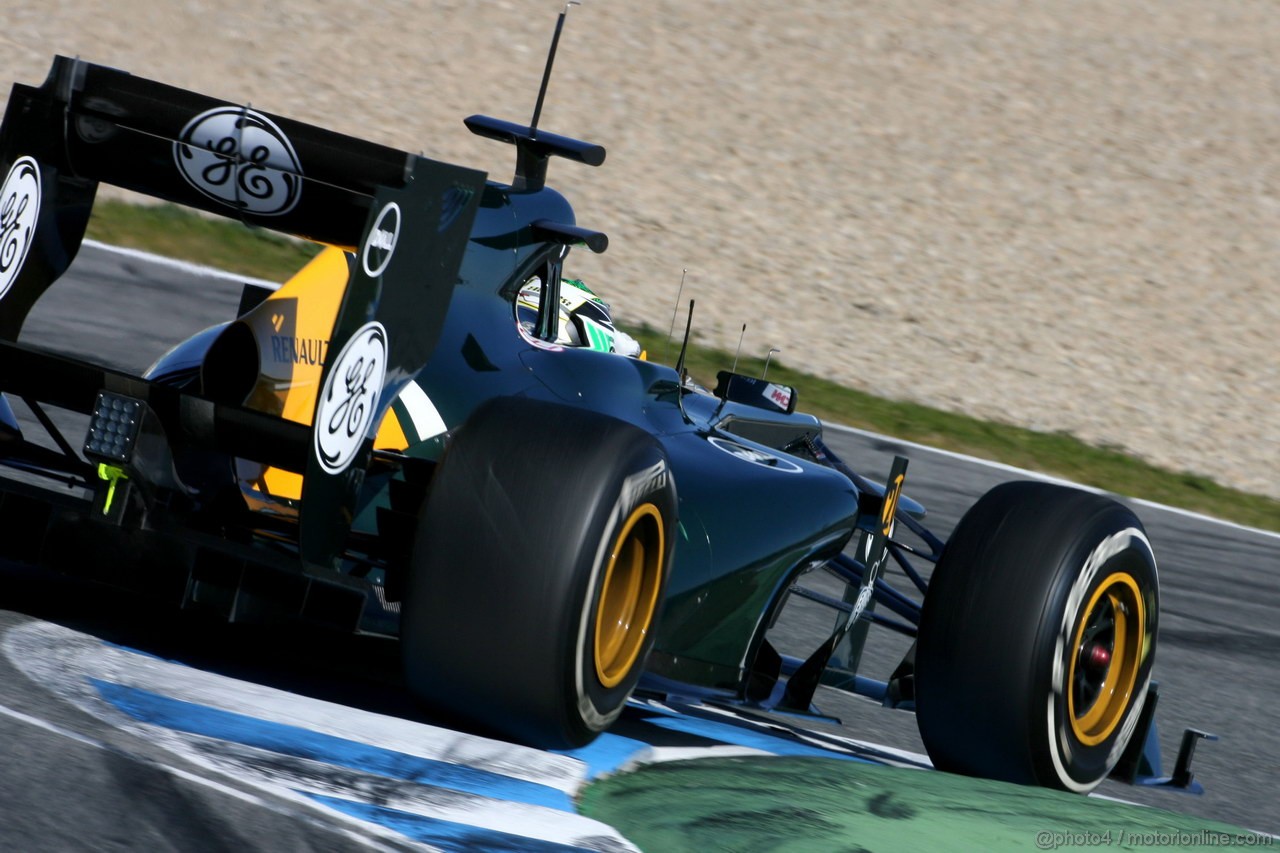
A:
<box><xmin>0</xmin><ymin>246</ymin><xmax>1280</xmax><ymax>850</ymax></box>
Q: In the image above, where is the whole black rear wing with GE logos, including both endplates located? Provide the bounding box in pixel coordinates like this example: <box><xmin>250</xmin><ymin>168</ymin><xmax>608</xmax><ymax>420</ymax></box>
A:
<box><xmin>0</xmin><ymin>56</ymin><xmax>485</xmax><ymax>562</ymax></box>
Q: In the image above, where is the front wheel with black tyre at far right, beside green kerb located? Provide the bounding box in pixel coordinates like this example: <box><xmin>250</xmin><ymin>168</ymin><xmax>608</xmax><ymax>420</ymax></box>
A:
<box><xmin>915</xmin><ymin>483</ymin><xmax>1160</xmax><ymax>793</ymax></box>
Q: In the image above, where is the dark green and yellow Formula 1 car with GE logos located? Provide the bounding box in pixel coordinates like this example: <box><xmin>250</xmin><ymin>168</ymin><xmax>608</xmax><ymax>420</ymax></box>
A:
<box><xmin>0</xmin><ymin>19</ymin><xmax>1189</xmax><ymax>792</ymax></box>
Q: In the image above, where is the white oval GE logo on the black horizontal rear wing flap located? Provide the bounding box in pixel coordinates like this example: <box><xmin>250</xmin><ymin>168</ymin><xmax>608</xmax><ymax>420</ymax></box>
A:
<box><xmin>173</xmin><ymin>105</ymin><xmax>302</xmax><ymax>216</ymax></box>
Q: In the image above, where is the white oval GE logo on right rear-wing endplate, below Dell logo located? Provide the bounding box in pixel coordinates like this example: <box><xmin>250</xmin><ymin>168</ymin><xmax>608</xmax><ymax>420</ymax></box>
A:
<box><xmin>312</xmin><ymin>321</ymin><xmax>387</xmax><ymax>474</ymax></box>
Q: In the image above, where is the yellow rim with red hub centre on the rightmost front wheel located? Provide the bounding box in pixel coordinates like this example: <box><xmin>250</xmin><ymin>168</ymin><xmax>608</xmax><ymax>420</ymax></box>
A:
<box><xmin>1068</xmin><ymin>573</ymin><xmax>1147</xmax><ymax>747</ymax></box>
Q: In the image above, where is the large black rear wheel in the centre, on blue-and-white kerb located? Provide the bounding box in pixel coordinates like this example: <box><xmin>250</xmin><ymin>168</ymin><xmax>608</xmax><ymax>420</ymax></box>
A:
<box><xmin>401</xmin><ymin>398</ymin><xmax>676</xmax><ymax>749</ymax></box>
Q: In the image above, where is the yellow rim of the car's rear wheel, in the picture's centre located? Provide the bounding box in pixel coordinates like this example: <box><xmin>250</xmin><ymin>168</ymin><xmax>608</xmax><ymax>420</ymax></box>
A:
<box><xmin>595</xmin><ymin>503</ymin><xmax>666</xmax><ymax>688</ymax></box>
